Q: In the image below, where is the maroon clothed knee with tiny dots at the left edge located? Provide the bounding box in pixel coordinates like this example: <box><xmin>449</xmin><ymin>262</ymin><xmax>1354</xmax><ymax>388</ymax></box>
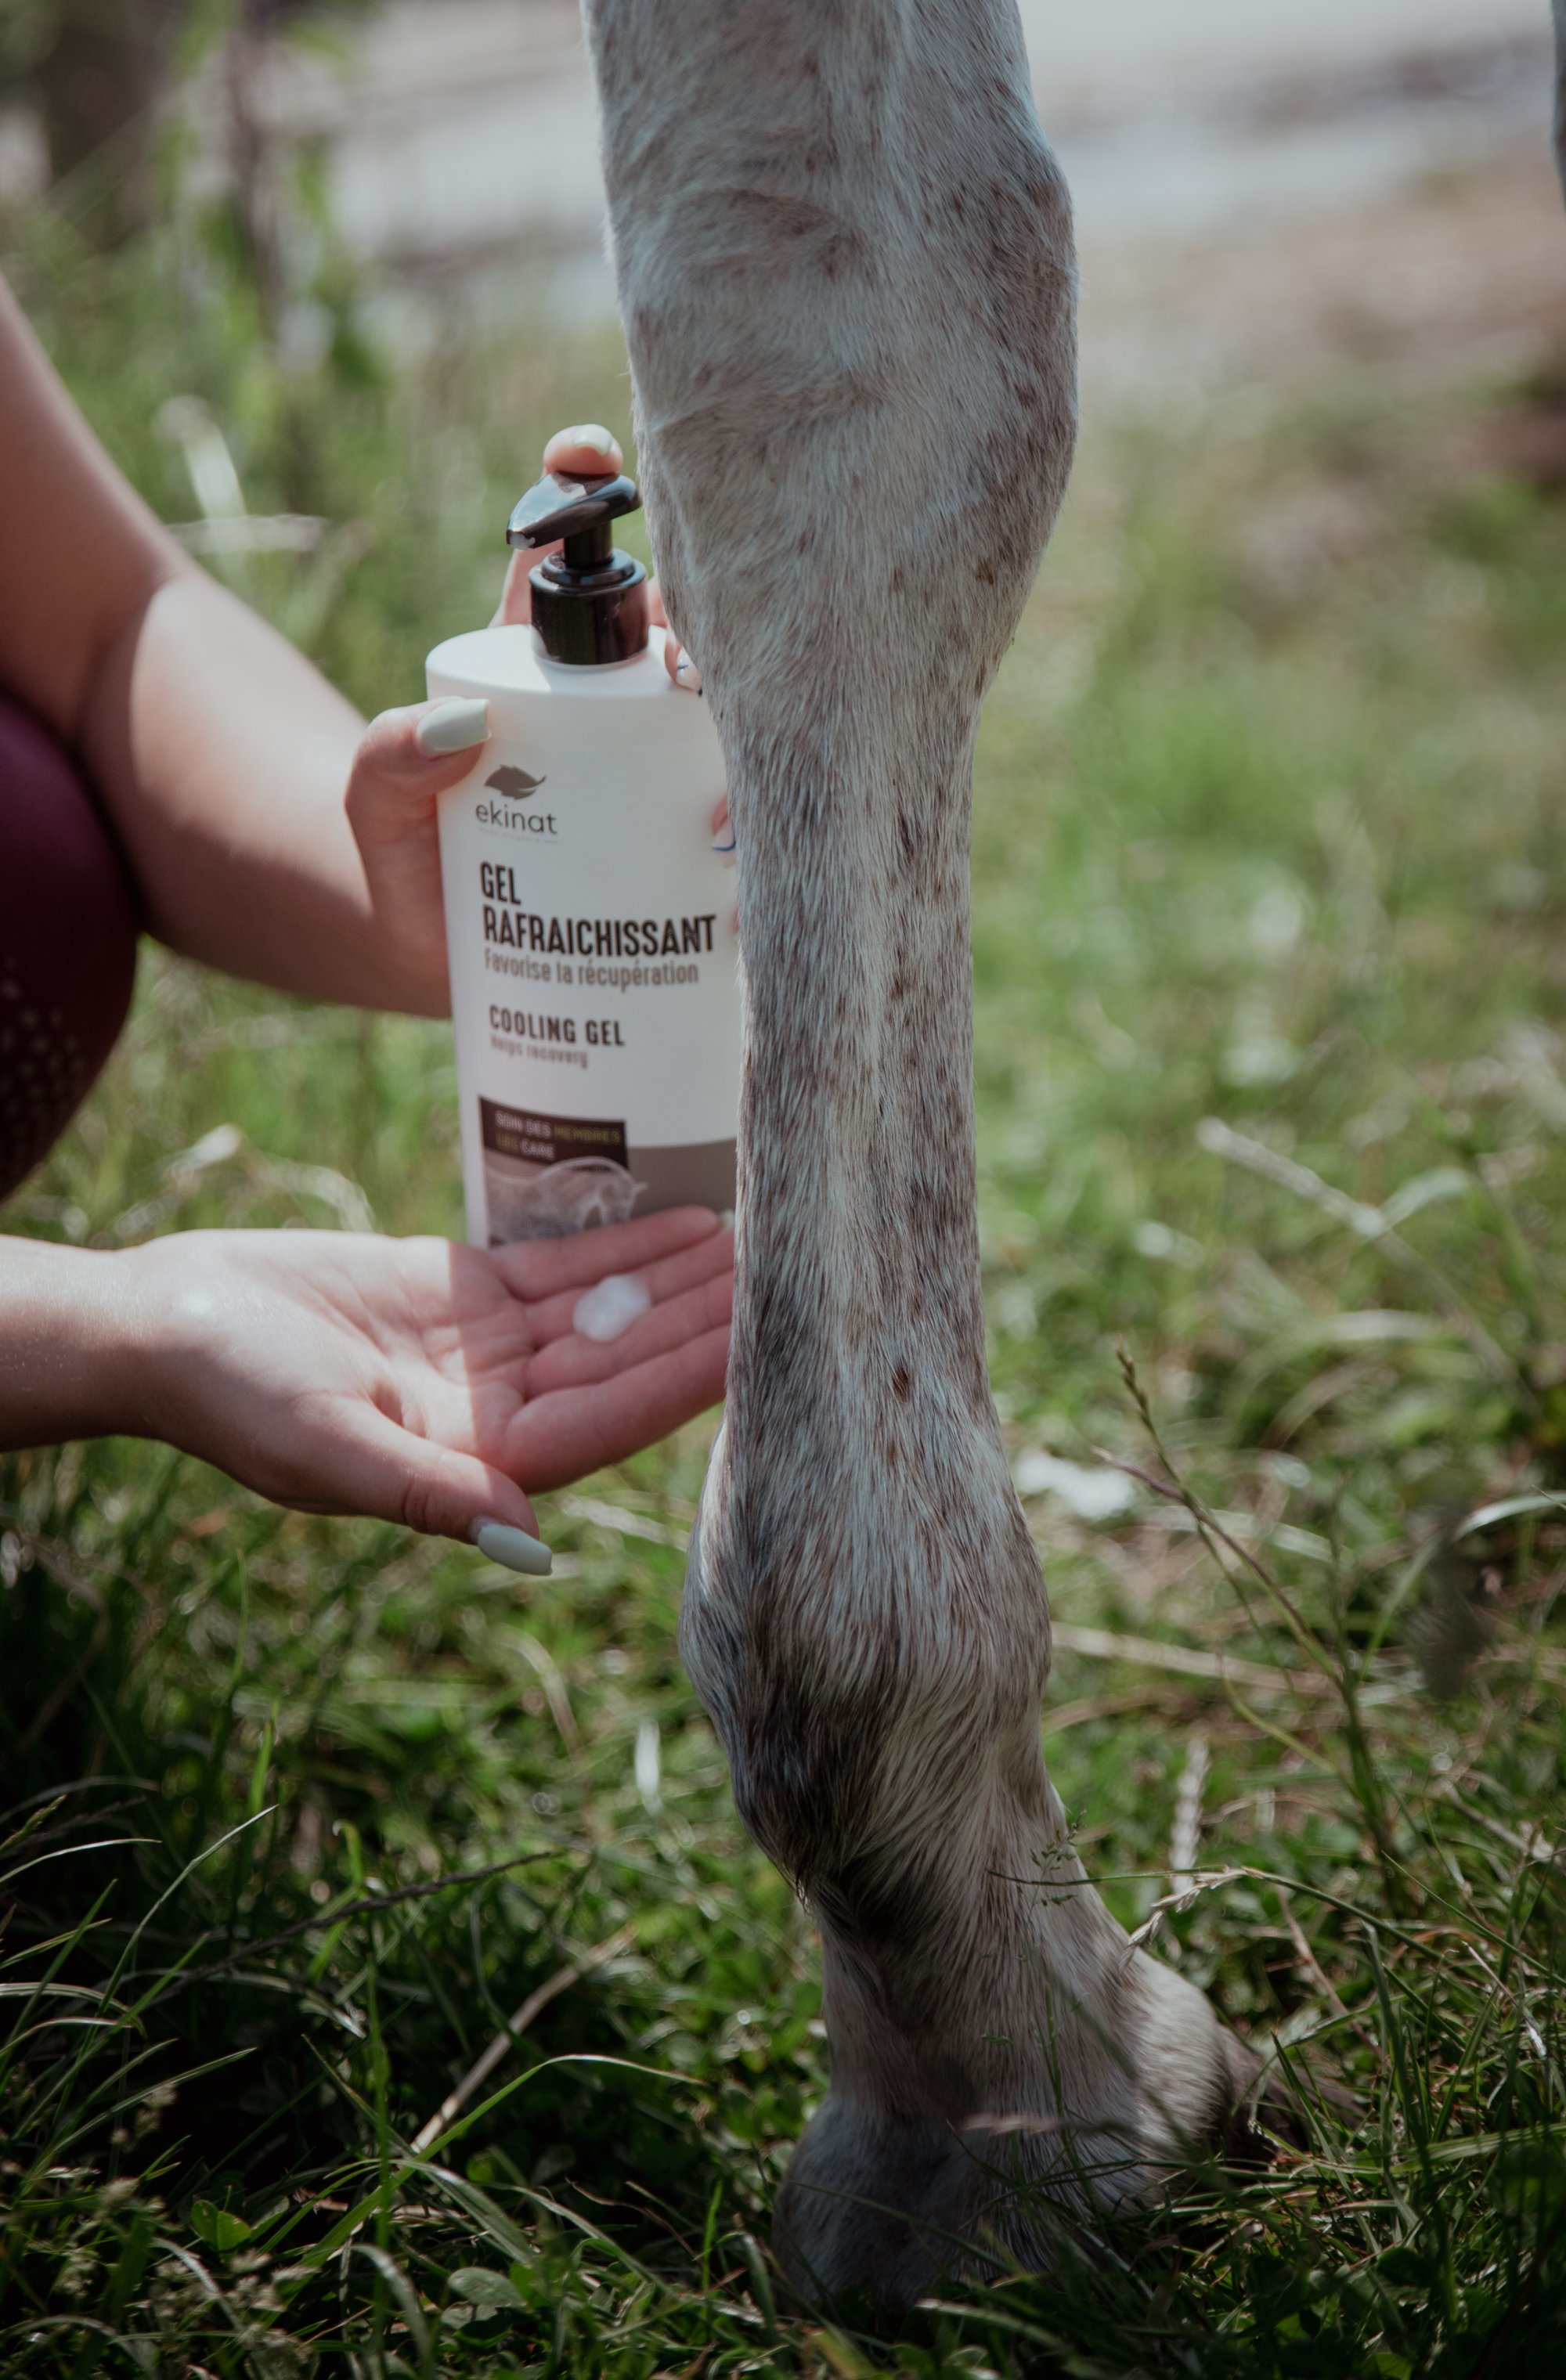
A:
<box><xmin>0</xmin><ymin>695</ymin><xmax>135</xmax><ymax>1199</ymax></box>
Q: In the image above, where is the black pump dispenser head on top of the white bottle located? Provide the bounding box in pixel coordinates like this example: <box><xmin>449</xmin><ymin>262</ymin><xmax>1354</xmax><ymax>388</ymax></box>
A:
<box><xmin>504</xmin><ymin>471</ymin><xmax>648</xmax><ymax>669</ymax></box>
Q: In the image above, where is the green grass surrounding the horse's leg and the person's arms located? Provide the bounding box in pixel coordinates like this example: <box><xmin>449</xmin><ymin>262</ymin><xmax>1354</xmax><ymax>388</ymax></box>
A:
<box><xmin>0</xmin><ymin>195</ymin><xmax>1566</xmax><ymax>2380</ymax></box>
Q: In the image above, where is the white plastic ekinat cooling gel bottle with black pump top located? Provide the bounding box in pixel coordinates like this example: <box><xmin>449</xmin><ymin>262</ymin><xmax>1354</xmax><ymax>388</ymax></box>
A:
<box><xmin>428</xmin><ymin>459</ymin><xmax>740</xmax><ymax>1247</ymax></box>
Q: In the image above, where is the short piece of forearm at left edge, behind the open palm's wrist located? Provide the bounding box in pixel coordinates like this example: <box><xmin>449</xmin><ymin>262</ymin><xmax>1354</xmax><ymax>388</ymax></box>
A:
<box><xmin>0</xmin><ymin>1240</ymin><xmax>153</xmax><ymax>1447</ymax></box>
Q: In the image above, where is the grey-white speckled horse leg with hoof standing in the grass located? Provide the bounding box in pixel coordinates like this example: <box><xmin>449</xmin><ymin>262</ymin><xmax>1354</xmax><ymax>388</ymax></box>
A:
<box><xmin>586</xmin><ymin>0</ymin><xmax>1247</xmax><ymax>2304</ymax></box>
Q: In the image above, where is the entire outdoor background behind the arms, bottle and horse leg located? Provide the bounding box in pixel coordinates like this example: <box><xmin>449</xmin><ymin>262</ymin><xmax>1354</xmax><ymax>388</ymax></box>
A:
<box><xmin>0</xmin><ymin>0</ymin><xmax>1566</xmax><ymax>2380</ymax></box>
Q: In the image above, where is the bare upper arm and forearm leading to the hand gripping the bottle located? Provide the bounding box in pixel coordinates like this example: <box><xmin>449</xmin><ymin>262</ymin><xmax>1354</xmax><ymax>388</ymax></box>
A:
<box><xmin>0</xmin><ymin>288</ymin><xmax>462</xmax><ymax>1012</ymax></box>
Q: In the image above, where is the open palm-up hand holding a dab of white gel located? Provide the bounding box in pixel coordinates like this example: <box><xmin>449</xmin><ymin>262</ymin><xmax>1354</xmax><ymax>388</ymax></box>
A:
<box><xmin>135</xmin><ymin>1206</ymin><xmax>733</xmax><ymax>1538</ymax></box>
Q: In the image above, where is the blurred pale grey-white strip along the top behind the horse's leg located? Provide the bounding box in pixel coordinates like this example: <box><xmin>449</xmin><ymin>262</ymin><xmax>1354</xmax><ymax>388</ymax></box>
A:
<box><xmin>298</xmin><ymin>0</ymin><xmax>1550</xmax><ymax>264</ymax></box>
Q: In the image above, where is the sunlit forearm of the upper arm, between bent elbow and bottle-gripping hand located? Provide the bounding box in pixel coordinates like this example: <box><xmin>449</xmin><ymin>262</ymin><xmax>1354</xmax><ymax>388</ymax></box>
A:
<box><xmin>78</xmin><ymin>585</ymin><xmax>445</xmax><ymax>1016</ymax></box>
